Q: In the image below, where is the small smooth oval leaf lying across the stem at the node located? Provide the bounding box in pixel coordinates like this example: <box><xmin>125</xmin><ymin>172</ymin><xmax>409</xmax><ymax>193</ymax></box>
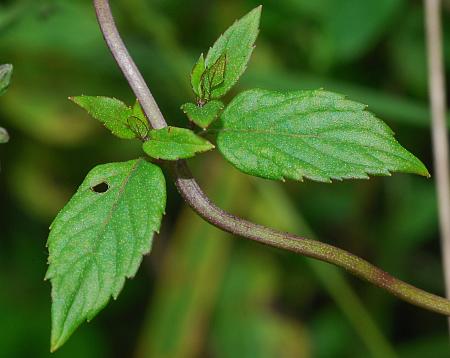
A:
<box><xmin>143</xmin><ymin>127</ymin><xmax>214</xmax><ymax>160</ymax></box>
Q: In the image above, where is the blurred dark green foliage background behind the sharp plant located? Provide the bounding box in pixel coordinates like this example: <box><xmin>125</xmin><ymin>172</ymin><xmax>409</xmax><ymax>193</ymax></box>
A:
<box><xmin>0</xmin><ymin>0</ymin><xmax>450</xmax><ymax>358</ymax></box>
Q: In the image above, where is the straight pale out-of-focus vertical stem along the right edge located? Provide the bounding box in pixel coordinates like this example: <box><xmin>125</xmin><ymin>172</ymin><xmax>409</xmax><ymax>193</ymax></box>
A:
<box><xmin>425</xmin><ymin>0</ymin><xmax>450</xmax><ymax>327</ymax></box>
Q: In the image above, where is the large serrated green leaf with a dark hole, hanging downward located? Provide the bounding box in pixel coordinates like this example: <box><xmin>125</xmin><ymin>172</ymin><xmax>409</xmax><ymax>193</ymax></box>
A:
<box><xmin>46</xmin><ymin>158</ymin><xmax>166</xmax><ymax>351</ymax></box>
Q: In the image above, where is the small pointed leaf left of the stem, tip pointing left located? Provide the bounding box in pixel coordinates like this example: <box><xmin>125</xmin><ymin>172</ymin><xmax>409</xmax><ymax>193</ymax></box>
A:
<box><xmin>69</xmin><ymin>96</ymin><xmax>136</xmax><ymax>139</ymax></box>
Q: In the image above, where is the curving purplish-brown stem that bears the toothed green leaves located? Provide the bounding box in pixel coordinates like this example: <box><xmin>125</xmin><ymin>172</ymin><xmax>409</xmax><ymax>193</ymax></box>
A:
<box><xmin>93</xmin><ymin>0</ymin><xmax>450</xmax><ymax>316</ymax></box>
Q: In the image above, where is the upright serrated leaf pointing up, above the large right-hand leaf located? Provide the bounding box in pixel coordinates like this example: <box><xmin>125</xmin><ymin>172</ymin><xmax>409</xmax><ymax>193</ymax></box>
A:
<box><xmin>205</xmin><ymin>6</ymin><xmax>261</xmax><ymax>99</ymax></box>
